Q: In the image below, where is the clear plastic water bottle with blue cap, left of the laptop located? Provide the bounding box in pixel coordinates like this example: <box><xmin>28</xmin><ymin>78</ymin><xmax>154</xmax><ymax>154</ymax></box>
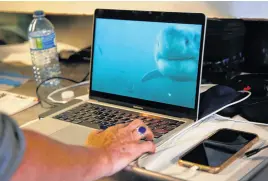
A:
<box><xmin>28</xmin><ymin>10</ymin><xmax>61</xmax><ymax>87</ymax></box>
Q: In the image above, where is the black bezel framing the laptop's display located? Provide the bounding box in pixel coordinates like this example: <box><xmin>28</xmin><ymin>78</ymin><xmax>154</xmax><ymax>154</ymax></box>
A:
<box><xmin>89</xmin><ymin>9</ymin><xmax>206</xmax><ymax>121</ymax></box>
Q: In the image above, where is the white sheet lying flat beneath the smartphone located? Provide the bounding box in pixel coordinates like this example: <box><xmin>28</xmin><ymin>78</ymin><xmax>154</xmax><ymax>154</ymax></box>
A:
<box><xmin>138</xmin><ymin>116</ymin><xmax>268</xmax><ymax>181</ymax></box>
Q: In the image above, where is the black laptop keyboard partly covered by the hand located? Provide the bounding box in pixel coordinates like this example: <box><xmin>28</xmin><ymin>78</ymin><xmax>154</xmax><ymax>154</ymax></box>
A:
<box><xmin>54</xmin><ymin>103</ymin><xmax>184</xmax><ymax>138</ymax></box>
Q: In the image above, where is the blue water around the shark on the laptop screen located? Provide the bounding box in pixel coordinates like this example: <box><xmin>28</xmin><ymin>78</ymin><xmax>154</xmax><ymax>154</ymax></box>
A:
<box><xmin>92</xmin><ymin>19</ymin><xmax>201</xmax><ymax>108</ymax></box>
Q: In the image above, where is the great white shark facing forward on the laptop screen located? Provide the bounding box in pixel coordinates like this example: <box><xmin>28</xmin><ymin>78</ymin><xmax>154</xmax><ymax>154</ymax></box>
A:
<box><xmin>142</xmin><ymin>26</ymin><xmax>201</xmax><ymax>82</ymax></box>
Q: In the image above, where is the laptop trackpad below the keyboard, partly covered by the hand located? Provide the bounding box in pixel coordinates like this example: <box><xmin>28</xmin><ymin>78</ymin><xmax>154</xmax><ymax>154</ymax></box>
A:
<box><xmin>49</xmin><ymin>124</ymin><xmax>94</xmax><ymax>146</ymax></box>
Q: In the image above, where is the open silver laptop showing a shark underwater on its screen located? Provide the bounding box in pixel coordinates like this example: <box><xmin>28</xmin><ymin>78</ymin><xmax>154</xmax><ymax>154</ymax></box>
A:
<box><xmin>25</xmin><ymin>9</ymin><xmax>206</xmax><ymax>148</ymax></box>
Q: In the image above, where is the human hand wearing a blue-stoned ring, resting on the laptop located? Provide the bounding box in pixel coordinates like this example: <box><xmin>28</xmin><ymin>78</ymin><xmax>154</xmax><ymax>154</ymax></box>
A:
<box><xmin>87</xmin><ymin>120</ymin><xmax>155</xmax><ymax>176</ymax></box>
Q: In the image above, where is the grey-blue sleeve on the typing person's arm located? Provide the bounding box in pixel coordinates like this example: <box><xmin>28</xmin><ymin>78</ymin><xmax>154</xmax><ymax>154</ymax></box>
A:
<box><xmin>0</xmin><ymin>113</ymin><xmax>25</xmax><ymax>181</ymax></box>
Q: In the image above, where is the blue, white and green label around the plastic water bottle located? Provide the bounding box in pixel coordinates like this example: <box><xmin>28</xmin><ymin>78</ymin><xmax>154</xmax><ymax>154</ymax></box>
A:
<box><xmin>29</xmin><ymin>33</ymin><xmax>56</xmax><ymax>50</ymax></box>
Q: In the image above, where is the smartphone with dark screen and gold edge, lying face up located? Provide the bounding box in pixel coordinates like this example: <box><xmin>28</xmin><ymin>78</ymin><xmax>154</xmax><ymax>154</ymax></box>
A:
<box><xmin>178</xmin><ymin>128</ymin><xmax>259</xmax><ymax>174</ymax></box>
